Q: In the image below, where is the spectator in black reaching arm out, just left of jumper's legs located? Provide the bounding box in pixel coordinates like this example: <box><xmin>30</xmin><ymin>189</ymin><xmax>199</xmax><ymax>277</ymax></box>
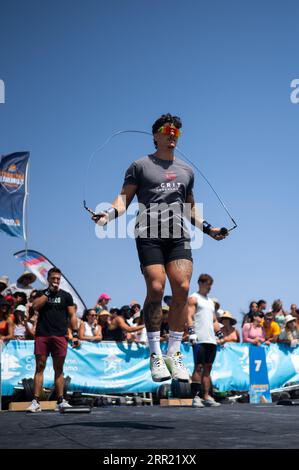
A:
<box><xmin>100</xmin><ymin>307</ymin><xmax>144</xmax><ymax>342</ymax></box>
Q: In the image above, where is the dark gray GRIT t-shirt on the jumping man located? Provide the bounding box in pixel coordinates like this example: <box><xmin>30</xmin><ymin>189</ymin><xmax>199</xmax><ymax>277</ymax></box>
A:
<box><xmin>124</xmin><ymin>155</ymin><xmax>194</xmax><ymax>238</ymax></box>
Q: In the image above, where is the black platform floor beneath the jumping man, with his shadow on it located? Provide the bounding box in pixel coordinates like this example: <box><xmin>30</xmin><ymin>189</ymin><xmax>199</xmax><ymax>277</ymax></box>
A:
<box><xmin>0</xmin><ymin>404</ymin><xmax>299</xmax><ymax>449</ymax></box>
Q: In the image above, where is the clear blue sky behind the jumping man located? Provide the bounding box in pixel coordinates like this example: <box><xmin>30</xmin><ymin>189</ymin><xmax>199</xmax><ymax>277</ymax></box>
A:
<box><xmin>0</xmin><ymin>0</ymin><xmax>299</xmax><ymax>324</ymax></box>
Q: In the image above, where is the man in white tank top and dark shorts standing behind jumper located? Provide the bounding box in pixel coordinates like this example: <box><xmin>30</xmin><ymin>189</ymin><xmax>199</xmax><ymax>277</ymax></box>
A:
<box><xmin>188</xmin><ymin>274</ymin><xmax>223</xmax><ymax>408</ymax></box>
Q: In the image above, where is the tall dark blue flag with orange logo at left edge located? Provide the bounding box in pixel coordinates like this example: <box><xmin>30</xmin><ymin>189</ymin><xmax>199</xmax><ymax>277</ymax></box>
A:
<box><xmin>0</xmin><ymin>152</ymin><xmax>29</xmax><ymax>240</ymax></box>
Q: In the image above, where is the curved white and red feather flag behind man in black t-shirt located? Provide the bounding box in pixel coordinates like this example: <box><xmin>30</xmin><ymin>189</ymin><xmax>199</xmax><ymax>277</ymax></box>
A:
<box><xmin>14</xmin><ymin>250</ymin><xmax>86</xmax><ymax>318</ymax></box>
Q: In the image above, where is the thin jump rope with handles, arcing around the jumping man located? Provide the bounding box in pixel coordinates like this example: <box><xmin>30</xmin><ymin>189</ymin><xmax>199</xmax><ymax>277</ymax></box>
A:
<box><xmin>83</xmin><ymin>129</ymin><xmax>238</xmax><ymax>235</ymax></box>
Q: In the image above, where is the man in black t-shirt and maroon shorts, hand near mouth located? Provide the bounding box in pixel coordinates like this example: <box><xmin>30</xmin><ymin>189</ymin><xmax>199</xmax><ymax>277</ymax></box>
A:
<box><xmin>27</xmin><ymin>268</ymin><xmax>80</xmax><ymax>413</ymax></box>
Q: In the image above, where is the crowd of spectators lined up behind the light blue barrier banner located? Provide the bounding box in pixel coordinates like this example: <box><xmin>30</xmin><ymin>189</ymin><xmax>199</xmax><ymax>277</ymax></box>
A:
<box><xmin>0</xmin><ymin>271</ymin><xmax>299</xmax><ymax>347</ymax></box>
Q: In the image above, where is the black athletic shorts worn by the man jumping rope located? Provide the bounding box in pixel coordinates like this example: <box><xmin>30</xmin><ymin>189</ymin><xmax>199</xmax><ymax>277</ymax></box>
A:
<box><xmin>136</xmin><ymin>238</ymin><xmax>192</xmax><ymax>268</ymax></box>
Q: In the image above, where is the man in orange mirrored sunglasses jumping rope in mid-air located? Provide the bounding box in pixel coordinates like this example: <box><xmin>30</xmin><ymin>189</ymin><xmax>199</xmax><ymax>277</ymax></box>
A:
<box><xmin>92</xmin><ymin>114</ymin><xmax>227</xmax><ymax>382</ymax></box>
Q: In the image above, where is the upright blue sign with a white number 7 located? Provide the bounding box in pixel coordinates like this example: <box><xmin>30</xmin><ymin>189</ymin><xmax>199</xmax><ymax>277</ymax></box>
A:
<box><xmin>249</xmin><ymin>344</ymin><xmax>272</xmax><ymax>403</ymax></box>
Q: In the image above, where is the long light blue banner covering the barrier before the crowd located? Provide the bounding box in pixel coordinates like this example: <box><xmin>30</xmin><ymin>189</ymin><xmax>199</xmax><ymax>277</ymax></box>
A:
<box><xmin>2</xmin><ymin>341</ymin><xmax>299</xmax><ymax>395</ymax></box>
